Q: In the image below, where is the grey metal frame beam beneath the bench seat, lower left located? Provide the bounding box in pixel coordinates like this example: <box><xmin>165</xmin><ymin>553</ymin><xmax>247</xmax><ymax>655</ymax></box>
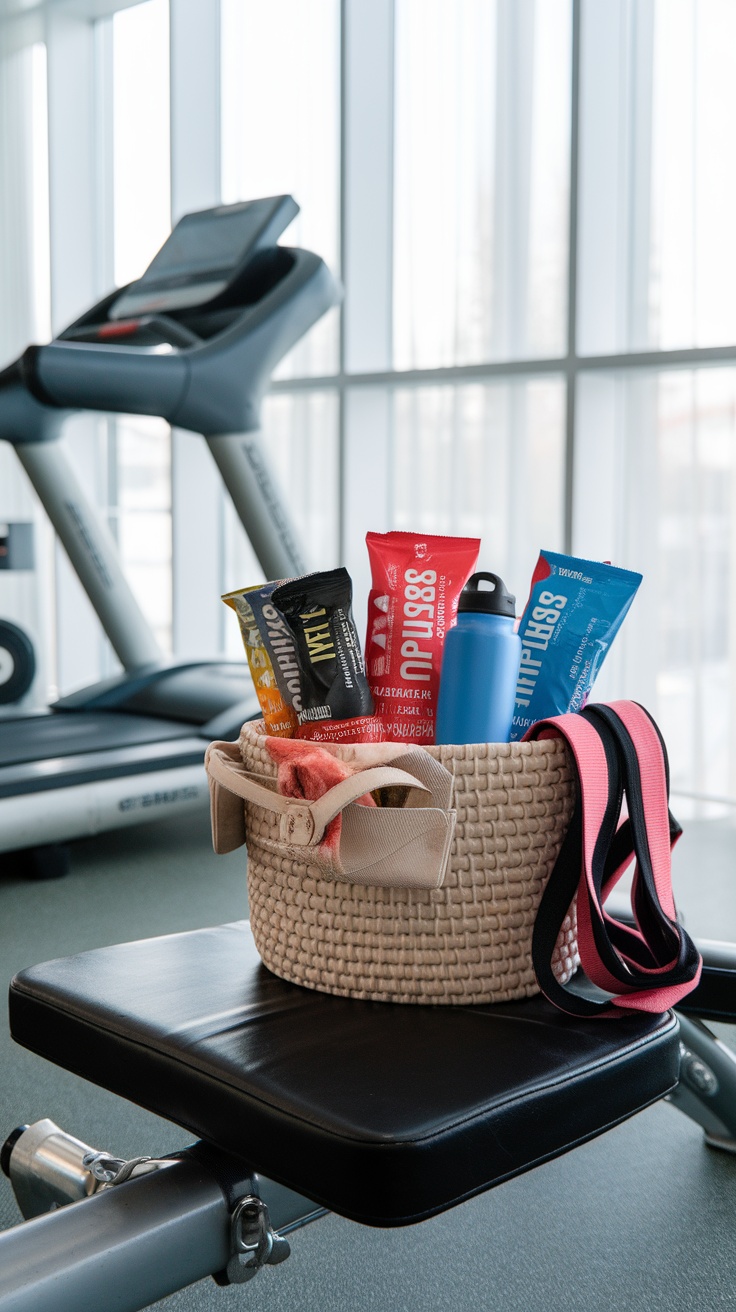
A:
<box><xmin>0</xmin><ymin>1123</ymin><xmax>324</xmax><ymax>1312</ymax></box>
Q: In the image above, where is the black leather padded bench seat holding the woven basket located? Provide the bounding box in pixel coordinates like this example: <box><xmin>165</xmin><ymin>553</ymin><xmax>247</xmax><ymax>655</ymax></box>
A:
<box><xmin>10</xmin><ymin>922</ymin><xmax>678</xmax><ymax>1225</ymax></box>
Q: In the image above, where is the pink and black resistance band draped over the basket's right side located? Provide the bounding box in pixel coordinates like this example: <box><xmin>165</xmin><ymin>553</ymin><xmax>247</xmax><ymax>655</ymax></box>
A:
<box><xmin>525</xmin><ymin>702</ymin><xmax>702</xmax><ymax>1017</ymax></box>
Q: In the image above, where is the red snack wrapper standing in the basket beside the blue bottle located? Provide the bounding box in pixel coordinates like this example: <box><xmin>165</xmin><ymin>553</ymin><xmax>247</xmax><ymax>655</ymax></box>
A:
<box><xmin>366</xmin><ymin>533</ymin><xmax>480</xmax><ymax>743</ymax></box>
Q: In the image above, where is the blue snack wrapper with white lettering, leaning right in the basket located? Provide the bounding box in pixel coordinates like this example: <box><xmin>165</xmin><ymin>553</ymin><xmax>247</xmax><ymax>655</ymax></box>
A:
<box><xmin>510</xmin><ymin>551</ymin><xmax>642</xmax><ymax>743</ymax></box>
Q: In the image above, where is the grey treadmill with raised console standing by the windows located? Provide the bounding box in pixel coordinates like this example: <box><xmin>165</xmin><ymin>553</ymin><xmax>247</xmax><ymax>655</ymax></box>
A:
<box><xmin>0</xmin><ymin>195</ymin><xmax>341</xmax><ymax>878</ymax></box>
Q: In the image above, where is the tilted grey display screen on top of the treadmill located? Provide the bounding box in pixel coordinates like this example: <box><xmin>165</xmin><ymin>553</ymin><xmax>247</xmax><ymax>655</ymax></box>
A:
<box><xmin>108</xmin><ymin>195</ymin><xmax>299</xmax><ymax>323</ymax></box>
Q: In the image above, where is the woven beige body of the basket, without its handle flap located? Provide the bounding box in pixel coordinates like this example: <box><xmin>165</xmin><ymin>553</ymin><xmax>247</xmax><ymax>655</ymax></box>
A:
<box><xmin>240</xmin><ymin>722</ymin><xmax>579</xmax><ymax>1005</ymax></box>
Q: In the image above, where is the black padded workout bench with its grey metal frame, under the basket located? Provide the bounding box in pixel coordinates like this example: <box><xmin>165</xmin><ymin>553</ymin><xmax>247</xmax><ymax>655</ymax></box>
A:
<box><xmin>0</xmin><ymin>922</ymin><xmax>736</xmax><ymax>1312</ymax></box>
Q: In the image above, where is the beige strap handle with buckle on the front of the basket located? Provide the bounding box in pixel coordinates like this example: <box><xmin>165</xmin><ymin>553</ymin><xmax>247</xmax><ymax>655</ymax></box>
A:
<box><xmin>205</xmin><ymin>743</ymin><xmax>430</xmax><ymax>853</ymax></box>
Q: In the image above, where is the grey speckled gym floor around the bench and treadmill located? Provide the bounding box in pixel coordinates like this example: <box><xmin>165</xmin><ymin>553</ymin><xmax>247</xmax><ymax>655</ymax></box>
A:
<box><xmin>0</xmin><ymin>797</ymin><xmax>736</xmax><ymax>1312</ymax></box>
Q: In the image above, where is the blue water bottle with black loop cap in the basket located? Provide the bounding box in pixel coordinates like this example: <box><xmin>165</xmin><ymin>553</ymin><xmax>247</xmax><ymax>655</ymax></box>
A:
<box><xmin>434</xmin><ymin>571</ymin><xmax>521</xmax><ymax>743</ymax></box>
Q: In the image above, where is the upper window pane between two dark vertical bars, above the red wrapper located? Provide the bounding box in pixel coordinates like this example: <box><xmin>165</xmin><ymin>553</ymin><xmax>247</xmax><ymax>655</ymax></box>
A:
<box><xmin>394</xmin><ymin>0</ymin><xmax>571</xmax><ymax>369</ymax></box>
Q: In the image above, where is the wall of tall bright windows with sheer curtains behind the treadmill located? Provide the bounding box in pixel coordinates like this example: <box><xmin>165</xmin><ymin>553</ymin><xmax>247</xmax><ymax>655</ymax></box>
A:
<box><xmin>0</xmin><ymin>0</ymin><xmax>736</xmax><ymax>815</ymax></box>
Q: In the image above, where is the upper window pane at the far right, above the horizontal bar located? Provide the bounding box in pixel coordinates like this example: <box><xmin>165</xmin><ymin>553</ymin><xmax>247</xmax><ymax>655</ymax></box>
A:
<box><xmin>579</xmin><ymin>0</ymin><xmax>736</xmax><ymax>354</ymax></box>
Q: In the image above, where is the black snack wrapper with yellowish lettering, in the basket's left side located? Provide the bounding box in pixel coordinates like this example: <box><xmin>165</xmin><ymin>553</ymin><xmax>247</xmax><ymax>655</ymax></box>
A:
<box><xmin>272</xmin><ymin>565</ymin><xmax>373</xmax><ymax>724</ymax></box>
